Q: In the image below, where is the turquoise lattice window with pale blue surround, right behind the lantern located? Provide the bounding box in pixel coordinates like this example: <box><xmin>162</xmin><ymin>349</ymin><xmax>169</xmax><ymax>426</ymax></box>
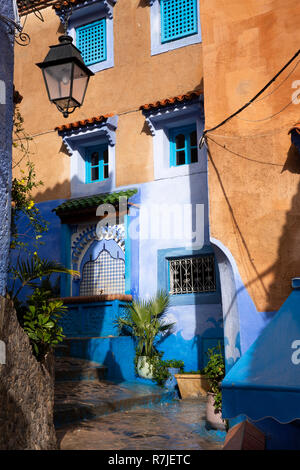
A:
<box><xmin>55</xmin><ymin>0</ymin><xmax>118</xmax><ymax>73</ymax></box>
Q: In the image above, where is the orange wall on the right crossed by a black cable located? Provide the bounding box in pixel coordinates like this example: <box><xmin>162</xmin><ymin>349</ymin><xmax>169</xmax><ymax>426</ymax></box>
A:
<box><xmin>200</xmin><ymin>0</ymin><xmax>300</xmax><ymax>311</ymax></box>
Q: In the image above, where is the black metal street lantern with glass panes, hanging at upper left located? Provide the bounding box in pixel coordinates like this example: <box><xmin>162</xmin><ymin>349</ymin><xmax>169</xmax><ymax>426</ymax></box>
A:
<box><xmin>36</xmin><ymin>35</ymin><xmax>94</xmax><ymax>118</ymax></box>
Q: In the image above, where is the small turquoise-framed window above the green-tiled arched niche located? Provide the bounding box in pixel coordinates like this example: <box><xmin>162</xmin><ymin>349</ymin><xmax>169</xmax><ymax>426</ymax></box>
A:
<box><xmin>86</xmin><ymin>145</ymin><xmax>109</xmax><ymax>183</ymax></box>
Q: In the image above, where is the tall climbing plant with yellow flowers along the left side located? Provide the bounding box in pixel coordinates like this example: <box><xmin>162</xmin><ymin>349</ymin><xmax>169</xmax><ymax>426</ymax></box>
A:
<box><xmin>8</xmin><ymin>108</ymin><xmax>79</xmax><ymax>361</ymax></box>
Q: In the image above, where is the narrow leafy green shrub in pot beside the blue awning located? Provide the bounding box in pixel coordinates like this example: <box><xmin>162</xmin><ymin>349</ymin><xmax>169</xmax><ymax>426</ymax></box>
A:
<box><xmin>203</xmin><ymin>343</ymin><xmax>225</xmax><ymax>413</ymax></box>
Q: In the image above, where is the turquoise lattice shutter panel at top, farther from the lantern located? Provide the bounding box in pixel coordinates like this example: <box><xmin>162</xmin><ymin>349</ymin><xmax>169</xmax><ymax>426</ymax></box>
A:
<box><xmin>160</xmin><ymin>0</ymin><xmax>198</xmax><ymax>43</ymax></box>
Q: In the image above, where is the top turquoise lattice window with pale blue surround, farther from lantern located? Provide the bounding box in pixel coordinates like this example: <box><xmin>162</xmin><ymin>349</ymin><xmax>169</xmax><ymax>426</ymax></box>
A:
<box><xmin>148</xmin><ymin>0</ymin><xmax>201</xmax><ymax>55</ymax></box>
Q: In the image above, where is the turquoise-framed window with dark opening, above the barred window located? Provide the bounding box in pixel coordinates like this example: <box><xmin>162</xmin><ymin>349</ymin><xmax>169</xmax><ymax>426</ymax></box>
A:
<box><xmin>169</xmin><ymin>124</ymin><xmax>198</xmax><ymax>166</ymax></box>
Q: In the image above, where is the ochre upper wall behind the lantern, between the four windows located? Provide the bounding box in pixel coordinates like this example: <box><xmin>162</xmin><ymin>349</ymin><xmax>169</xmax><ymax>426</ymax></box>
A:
<box><xmin>15</xmin><ymin>0</ymin><xmax>203</xmax><ymax>201</ymax></box>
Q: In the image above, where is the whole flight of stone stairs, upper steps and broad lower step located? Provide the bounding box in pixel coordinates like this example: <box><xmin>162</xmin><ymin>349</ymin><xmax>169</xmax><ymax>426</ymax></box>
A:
<box><xmin>54</xmin><ymin>356</ymin><xmax>174</xmax><ymax>428</ymax></box>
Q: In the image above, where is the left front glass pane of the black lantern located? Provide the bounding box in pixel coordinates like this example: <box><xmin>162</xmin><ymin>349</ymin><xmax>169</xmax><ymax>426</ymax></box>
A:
<box><xmin>43</xmin><ymin>63</ymin><xmax>73</xmax><ymax>101</ymax></box>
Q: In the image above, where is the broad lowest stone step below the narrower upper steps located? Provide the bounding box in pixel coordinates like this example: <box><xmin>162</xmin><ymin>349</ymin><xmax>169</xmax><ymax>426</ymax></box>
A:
<box><xmin>54</xmin><ymin>380</ymin><xmax>174</xmax><ymax>428</ymax></box>
